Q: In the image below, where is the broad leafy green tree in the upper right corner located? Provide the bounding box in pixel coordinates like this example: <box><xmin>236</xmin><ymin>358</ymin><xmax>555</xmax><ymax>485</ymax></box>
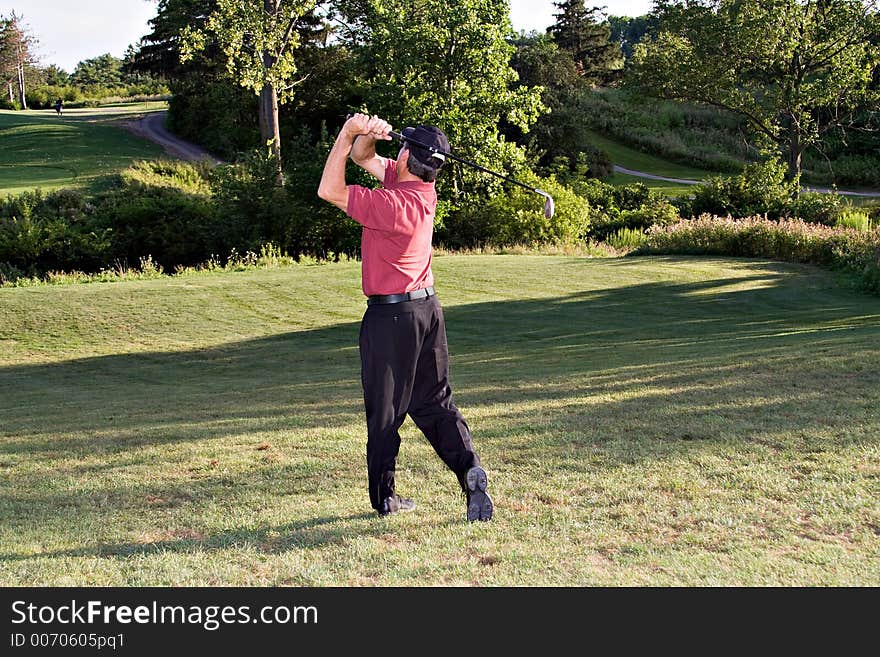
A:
<box><xmin>627</xmin><ymin>0</ymin><xmax>880</xmax><ymax>180</ymax></box>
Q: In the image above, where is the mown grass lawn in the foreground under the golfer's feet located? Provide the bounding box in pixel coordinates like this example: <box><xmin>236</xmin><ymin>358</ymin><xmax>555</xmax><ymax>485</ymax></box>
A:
<box><xmin>0</xmin><ymin>256</ymin><xmax>880</xmax><ymax>586</ymax></box>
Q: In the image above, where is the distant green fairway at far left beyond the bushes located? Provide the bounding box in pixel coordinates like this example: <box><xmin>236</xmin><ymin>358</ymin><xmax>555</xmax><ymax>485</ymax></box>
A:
<box><xmin>0</xmin><ymin>102</ymin><xmax>166</xmax><ymax>196</ymax></box>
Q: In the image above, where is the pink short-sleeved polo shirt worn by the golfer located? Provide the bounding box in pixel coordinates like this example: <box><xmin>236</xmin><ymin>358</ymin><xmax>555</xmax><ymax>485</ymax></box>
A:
<box><xmin>346</xmin><ymin>160</ymin><xmax>437</xmax><ymax>296</ymax></box>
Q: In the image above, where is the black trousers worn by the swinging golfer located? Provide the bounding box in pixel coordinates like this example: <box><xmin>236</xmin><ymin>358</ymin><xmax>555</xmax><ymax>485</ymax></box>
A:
<box><xmin>360</xmin><ymin>296</ymin><xmax>480</xmax><ymax>509</ymax></box>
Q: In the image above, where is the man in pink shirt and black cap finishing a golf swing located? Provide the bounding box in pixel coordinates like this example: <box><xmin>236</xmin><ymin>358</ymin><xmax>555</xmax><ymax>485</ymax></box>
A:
<box><xmin>318</xmin><ymin>114</ymin><xmax>493</xmax><ymax>521</ymax></box>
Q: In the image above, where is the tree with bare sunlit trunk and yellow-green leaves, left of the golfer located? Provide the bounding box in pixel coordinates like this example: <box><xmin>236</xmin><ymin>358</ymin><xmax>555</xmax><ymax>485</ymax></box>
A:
<box><xmin>181</xmin><ymin>0</ymin><xmax>324</xmax><ymax>185</ymax></box>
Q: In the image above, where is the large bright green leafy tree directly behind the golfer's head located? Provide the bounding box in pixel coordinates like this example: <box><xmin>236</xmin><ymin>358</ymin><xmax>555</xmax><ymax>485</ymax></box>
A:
<box><xmin>352</xmin><ymin>0</ymin><xmax>543</xmax><ymax>198</ymax></box>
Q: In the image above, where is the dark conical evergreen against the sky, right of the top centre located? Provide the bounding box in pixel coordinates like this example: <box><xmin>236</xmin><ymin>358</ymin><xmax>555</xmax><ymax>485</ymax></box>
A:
<box><xmin>547</xmin><ymin>0</ymin><xmax>623</xmax><ymax>84</ymax></box>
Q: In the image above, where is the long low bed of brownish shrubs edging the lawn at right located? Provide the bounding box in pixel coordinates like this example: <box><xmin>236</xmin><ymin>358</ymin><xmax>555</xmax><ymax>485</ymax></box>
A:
<box><xmin>634</xmin><ymin>215</ymin><xmax>880</xmax><ymax>294</ymax></box>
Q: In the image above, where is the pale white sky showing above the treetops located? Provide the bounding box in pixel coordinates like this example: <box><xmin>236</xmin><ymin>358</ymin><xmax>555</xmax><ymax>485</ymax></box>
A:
<box><xmin>0</xmin><ymin>0</ymin><xmax>651</xmax><ymax>73</ymax></box>
